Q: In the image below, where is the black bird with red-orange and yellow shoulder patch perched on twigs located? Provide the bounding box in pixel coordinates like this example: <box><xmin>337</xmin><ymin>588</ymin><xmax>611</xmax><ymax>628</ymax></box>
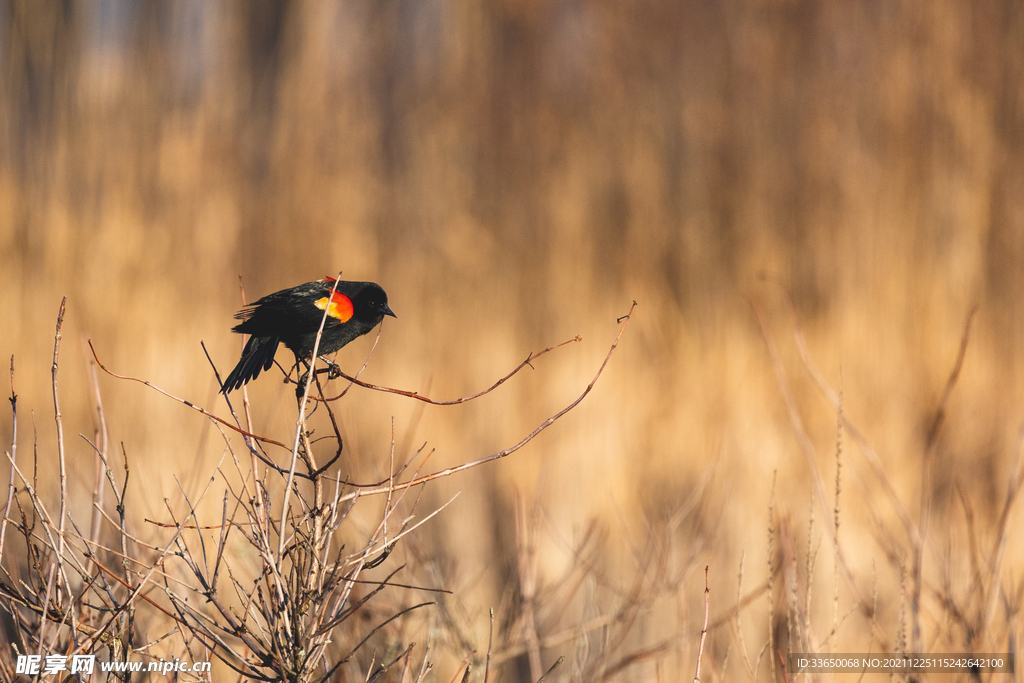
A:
<box><xmin>220</xmin><ymin>278</ymin><xmax>397</xmax><ymax>393</ymax></box>
